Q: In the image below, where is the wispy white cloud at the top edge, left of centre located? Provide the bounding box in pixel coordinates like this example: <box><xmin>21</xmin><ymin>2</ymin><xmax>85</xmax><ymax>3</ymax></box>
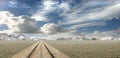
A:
<box><xmin>32</xmin><ymin>0</ymin><xmax>70</xmax><ymax>21</ymax></box>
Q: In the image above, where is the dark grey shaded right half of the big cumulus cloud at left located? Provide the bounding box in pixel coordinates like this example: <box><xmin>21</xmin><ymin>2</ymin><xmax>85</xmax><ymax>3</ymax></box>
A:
<box><xmin>17</xmin><ymin>16</ymin><xmax>37</xmax><ymax>33</ymax></box>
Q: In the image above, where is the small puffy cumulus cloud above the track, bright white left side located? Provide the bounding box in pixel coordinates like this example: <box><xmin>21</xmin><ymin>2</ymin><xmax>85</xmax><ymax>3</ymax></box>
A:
<box><xmin>40</xmin><ymin>23</ymin><xmax>68</xmax><ymax>34</ymax></box>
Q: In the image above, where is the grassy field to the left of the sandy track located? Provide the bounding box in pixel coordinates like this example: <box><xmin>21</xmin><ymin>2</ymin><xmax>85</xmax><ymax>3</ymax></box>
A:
<box><xmin>0</xmin><ymin>41</ymin><xmax>36</xmax><ymax>58</ymax></box>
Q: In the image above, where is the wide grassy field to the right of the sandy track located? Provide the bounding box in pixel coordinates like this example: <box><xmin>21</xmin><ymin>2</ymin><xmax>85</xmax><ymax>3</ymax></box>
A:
<box><xmin>47</xmin><ymin>41</ymin><xmax>120</xmax><ymax>58</ymax></box>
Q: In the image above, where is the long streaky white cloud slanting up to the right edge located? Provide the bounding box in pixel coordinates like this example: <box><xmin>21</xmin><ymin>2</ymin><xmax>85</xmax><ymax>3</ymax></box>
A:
<box><xmin>60</xmin><ymin>4</ymin><xmax>120</xmax><ymax>25</ymax></box>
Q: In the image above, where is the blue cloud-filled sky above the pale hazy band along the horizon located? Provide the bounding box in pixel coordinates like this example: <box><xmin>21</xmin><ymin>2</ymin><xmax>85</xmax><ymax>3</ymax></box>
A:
<box><xmin>0</xmin><ymin>0</ymin><xmax>120</xmax><ymax>34</ymax></box>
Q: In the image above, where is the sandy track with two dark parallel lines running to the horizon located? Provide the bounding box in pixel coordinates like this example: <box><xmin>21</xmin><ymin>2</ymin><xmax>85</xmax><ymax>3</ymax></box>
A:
<box><xmin>12</xmin><ymin>42</ymin><xmax>70</xmax><ymax>58</ymax></box>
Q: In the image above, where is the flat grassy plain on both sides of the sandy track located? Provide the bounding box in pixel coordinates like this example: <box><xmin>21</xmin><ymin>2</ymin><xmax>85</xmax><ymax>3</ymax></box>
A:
<box><xmin>0</xmin><ymin>40</ymin><xmax>120</xmax><ymax>58</ymax></box>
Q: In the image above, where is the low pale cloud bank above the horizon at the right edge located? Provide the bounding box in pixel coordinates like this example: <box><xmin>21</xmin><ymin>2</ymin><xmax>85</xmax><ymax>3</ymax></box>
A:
<box><xmin>86</xmin><ymin>29</ymin><xmax>120</xmax><ymax>40</ymax></box>
